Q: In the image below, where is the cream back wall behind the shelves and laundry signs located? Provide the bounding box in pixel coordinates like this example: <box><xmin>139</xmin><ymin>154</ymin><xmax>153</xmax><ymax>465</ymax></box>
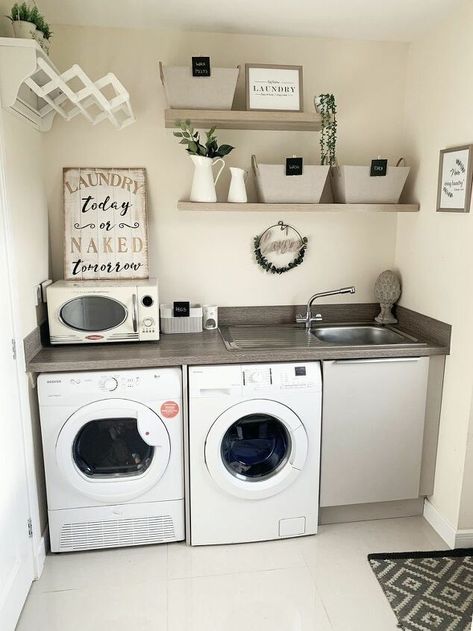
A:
<box><xmin>44</xmin><ymin>27</ymin><xmax>407</xmax><ymax>305</ymax></box>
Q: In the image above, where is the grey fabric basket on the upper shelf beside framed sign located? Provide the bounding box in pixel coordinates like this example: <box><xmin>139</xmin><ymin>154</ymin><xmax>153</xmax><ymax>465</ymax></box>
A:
<box><xmin>159</xmin><ymin>62</ymin><xmax>240</xmax><ymax>110</ymax></box>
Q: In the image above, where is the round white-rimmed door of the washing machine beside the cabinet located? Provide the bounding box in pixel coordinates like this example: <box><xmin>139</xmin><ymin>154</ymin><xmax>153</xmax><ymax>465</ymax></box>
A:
<box><xmin>205</xmin><ymin>399</ymin><xmax>308</xmax><ymax>499</ymax></box>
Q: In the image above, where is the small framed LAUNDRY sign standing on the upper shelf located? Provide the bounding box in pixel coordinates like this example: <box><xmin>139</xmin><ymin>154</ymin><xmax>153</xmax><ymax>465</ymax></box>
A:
<box><xmin>245</xmin><ymin>64</ymin><xmax>304</xmax><ymax>112</ymax></box>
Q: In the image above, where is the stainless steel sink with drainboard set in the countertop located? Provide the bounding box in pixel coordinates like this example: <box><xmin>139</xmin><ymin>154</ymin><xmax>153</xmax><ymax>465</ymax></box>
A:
<box><xmin>220</xmin><ymin>323</ymin><xmax>423</xmax><ymax>351</ymax></box>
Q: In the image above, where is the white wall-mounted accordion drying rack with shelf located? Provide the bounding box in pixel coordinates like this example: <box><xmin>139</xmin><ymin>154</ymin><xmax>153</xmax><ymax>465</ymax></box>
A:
<box><xmin>0</xmin><ymin>37</ymin><xmax>135</xmax><ymax>131</ymax></box>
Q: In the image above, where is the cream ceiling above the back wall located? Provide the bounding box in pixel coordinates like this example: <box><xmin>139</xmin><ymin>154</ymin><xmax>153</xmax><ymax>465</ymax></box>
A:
<box><xmin>36</xmin><ymin>0</ymin><xmax>464</xmax><ymax>41</ymax></box>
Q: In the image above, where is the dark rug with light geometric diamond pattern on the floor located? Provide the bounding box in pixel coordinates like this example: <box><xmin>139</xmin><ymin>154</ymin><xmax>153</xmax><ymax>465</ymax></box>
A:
<box><xmin>368</xmin><ymin>548</ymin><xmax>473</xmax><ymax>631</ymax></box>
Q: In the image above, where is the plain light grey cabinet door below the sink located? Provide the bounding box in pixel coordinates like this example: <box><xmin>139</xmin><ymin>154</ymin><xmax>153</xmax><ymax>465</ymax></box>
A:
<box><xmin>320</xmin><ymin>357</ymin><xmax>429</xmax><ymax>506</ymax></box>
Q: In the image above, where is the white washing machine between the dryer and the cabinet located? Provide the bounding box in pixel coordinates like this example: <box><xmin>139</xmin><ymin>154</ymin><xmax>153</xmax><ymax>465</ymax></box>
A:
<box><xmin>188</xmin><ymin>362</ymin><xmax>322</xmax><ymax>545</ymax></box>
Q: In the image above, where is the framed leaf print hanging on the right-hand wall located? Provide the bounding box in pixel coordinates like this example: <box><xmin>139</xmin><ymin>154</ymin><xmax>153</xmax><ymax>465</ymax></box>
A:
<box><xmin>437</xmin><ymin>145</ymin><xmax>473</xmax><ymax>213</ymax></box>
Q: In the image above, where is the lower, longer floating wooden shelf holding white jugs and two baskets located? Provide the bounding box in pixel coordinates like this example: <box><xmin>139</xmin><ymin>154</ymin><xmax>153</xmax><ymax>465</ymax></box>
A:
<box><xmin>177</xmin><ymin>202</ymin><xmax>419</xmax><ymax>213</ymax></box>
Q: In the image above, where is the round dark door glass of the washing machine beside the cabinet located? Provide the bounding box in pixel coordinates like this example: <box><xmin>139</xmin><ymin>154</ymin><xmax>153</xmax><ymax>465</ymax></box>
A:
<box><xmin>221</xmin><ymin>414</ymin><xmax>291</xmax><ymax>480</ymax></box>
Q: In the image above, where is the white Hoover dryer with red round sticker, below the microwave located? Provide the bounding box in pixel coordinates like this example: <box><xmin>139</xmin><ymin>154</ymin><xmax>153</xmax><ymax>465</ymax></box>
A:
<box><xmin>38</xmin><ymin>368</ymin><xmax>184</xmax><ymax>552</ymax></box>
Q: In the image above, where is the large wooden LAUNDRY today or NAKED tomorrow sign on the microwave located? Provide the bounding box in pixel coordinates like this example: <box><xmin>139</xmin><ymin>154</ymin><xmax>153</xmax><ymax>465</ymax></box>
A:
<box><xmin>63</xmin><ymin>167</ymin><xmax>149</xmax><ymax>280</ymax></box>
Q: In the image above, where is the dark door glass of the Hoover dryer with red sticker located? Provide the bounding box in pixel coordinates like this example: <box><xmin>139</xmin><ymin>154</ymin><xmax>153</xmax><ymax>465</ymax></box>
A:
<box><xmin>72</xmin><ymin>418</ymin><xmax>154</xmax><ymax>478</ymax></box>
